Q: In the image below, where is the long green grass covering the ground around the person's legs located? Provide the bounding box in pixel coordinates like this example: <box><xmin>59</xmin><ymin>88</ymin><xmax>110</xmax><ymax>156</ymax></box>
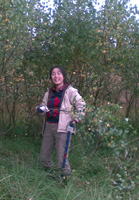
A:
<box><xmin>0</xmin><ymin>136</ymin><xmax>139</xmax><ymax>200</ymax></box>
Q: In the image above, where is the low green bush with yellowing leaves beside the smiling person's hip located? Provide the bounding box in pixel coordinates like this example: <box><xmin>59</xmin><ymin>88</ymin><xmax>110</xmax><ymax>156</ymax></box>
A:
<box><xmin>79</xmin><ymin>102</ymin><xmax>137</xmax><ymax>153</ymax></box>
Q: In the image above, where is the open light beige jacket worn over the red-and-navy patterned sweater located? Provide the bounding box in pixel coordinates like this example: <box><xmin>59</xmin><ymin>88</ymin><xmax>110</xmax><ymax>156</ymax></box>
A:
<box><xmin>41</xmin><ymin>85</ymin><xmax>86</xmax><ymax>132</ymax></box>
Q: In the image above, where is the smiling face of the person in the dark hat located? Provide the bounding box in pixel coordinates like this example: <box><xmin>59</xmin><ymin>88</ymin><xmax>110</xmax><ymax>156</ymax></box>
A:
<box><xmin>51</xmin><ymin>68</ymin><xmax>64</xmax><ymax>88</ymax></box>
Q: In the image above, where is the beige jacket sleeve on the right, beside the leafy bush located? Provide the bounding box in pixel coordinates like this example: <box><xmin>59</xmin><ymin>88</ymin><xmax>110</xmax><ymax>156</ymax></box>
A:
<box><xmin>70</xmin><ymin>88</ymin><xmax>86</xmax><ymax>122</ymax></box>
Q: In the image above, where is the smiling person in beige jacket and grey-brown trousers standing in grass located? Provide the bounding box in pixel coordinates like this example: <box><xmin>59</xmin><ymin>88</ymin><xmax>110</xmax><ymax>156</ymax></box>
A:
<box><xmin>37</xmin><ymin>66</ymin><xmax>86</xmax><ymax>180</ymax></box>
